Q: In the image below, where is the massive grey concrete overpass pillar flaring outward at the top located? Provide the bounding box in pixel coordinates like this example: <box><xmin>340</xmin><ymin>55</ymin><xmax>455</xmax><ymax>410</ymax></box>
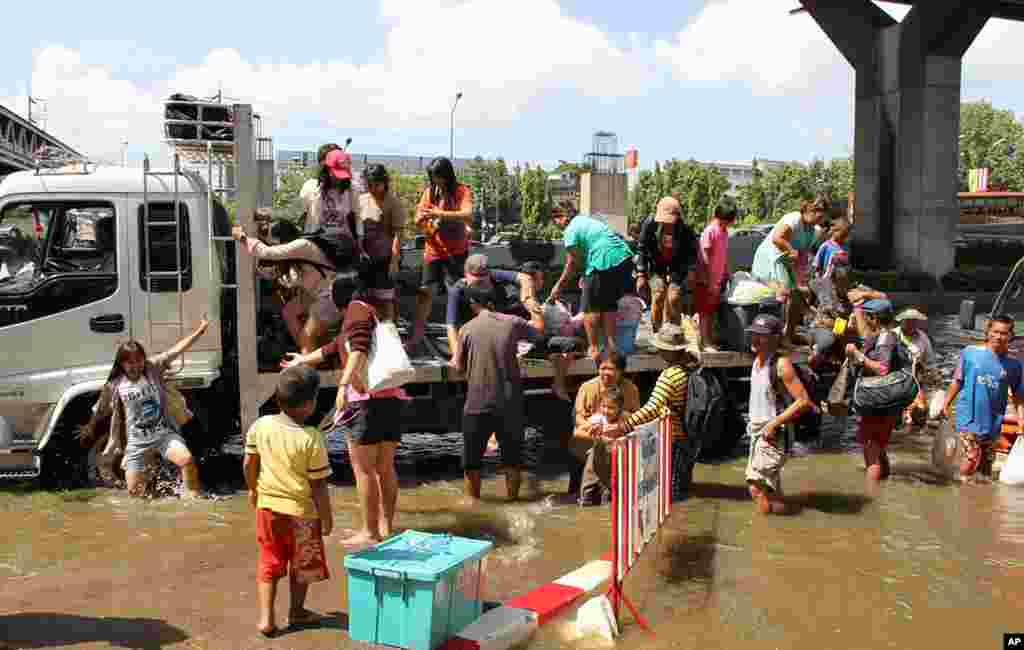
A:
<box><xmin>802</xmin><ymin>0</ymin><xmax>996</xmax><ymax>277</ymax></box>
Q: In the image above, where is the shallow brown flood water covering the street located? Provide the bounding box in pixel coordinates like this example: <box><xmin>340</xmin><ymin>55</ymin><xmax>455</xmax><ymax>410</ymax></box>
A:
<box><xmin>0</xmin><ymin>317</ymin><xmax>1024</xmax><ymax>650</ymax></box>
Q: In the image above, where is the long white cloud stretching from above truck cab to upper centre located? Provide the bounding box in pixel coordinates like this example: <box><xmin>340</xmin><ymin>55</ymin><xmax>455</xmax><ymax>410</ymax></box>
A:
<box><xmin>6</xmin><ymin>0</ymin><xmax>650</xmax><ymax>160</ymax></box>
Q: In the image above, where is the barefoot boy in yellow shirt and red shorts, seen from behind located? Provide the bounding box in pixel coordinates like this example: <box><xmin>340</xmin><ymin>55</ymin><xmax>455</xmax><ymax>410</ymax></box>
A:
<box><xmin>245</xmin><ymin>366</ymin><xmax>334</xmax><ymax>637</ymax></box>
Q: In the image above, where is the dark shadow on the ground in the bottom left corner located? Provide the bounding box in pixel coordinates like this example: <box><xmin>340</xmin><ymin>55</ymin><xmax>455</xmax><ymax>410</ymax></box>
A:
<box><xmin>0</xmin><ymin>612</ymin><xmax>188</xmax><ymax>648</ymax></box>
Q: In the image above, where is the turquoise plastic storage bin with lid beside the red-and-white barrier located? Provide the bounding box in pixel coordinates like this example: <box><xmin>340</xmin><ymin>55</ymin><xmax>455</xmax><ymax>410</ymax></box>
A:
<box><xmin>345</xmin><ymin>530</ymin><xmax>494</xmax><ymax>650</ymax></box>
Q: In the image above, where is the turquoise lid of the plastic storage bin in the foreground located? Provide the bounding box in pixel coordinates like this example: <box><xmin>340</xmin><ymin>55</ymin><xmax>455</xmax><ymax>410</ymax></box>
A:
<box><xmin>345</xmin><ymin>530</ymin><xmax>494</xmax><ymax>580</ymax></box>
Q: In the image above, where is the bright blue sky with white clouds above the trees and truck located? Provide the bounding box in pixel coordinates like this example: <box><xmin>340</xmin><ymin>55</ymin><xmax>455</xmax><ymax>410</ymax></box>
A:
<box><xmin>0</xmin><ymin>0</ymin><xmax>1024</xmax><ymax>166</ymax></box>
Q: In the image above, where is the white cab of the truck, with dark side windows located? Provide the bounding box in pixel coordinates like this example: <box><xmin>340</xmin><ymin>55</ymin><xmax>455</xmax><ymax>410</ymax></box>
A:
<box><xmin>0</xmin><ymin>163</ymin><xmax>228</xmax><ymax>477</ymax></box>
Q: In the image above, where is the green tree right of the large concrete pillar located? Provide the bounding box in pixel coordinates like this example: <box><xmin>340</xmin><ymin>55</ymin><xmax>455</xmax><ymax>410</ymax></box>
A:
<box><xmin>959</xmin><ymin>101</ymin><xmax>1024</xmax><ymax>191</ymax></box>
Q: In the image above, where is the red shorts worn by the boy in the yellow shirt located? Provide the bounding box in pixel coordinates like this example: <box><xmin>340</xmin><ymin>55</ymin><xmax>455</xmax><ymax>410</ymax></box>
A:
<box><xmin>256</xmin><ymin>508</ymin><xmax>330</xmax><ymax>584</ymax></box>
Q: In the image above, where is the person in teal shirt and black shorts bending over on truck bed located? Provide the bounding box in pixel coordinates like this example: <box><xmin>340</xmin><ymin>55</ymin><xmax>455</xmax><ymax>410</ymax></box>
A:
<box><xmin>548</xmin><ymin>206</ymin><xmax>633</xmax><ymax>363</ymax></box>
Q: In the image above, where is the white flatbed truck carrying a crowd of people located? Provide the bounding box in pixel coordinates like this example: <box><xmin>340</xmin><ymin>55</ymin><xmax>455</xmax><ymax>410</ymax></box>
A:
<box><xmin>0</xmin><ymin>104</ymin><xmax>750</xmax><ymax>485</ymax></box>
